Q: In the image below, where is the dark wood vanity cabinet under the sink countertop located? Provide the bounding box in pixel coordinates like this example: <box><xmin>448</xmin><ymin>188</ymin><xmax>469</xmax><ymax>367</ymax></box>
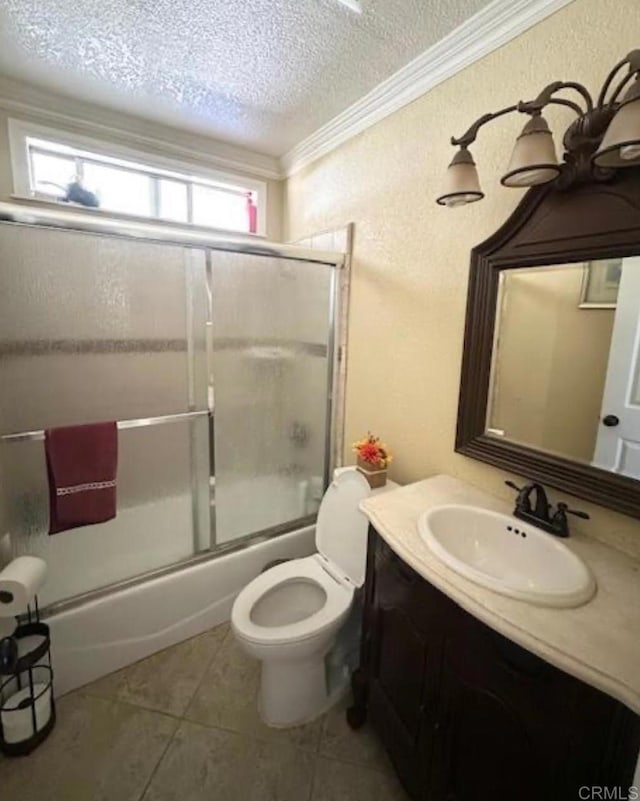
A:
<box><xmin>348</xmin><ymin>528</ymin><xmax>640</xmax><ymax>801</ymax></box>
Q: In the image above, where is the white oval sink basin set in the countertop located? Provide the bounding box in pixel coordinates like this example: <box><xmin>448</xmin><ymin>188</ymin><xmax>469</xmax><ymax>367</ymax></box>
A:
<box><xmin>418</xmin><ymin>505</ymin><xmax>596</xmax><ymax>607</ymax></box>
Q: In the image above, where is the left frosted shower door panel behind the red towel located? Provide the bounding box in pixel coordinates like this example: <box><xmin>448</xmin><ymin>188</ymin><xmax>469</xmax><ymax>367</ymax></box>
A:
<box><xmin>0</xmin><ymin>224</ymin><xmax>211</xmax><ymax>606</ymax></box>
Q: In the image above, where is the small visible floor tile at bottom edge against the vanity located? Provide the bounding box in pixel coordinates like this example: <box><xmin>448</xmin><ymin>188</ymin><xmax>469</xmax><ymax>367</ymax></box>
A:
<box><xmin>311</xmin><ymin>757</ymin><xmax>408</xmax><ymax>801</ymax></box>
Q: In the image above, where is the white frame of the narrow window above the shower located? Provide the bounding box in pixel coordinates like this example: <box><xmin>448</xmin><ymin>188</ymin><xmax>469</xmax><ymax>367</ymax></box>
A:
<box><xmin>8</xmin><ymin>118</ymin><xmax>267</xmax><ymax>237</ymax></box>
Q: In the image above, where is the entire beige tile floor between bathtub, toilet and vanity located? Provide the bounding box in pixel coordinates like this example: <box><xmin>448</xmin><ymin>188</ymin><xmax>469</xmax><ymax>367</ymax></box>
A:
<box><xmin>0</xmin><ymin>624</ymin><xmax>406</xmax><ymax>801</ymax></box>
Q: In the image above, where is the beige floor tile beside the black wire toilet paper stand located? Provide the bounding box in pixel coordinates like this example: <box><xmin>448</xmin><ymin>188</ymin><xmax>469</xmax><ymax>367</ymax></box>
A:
<box><xmin>0</xmin><ymin>693</ymin><xmax>178</xmax><ymax>801</ymax></box>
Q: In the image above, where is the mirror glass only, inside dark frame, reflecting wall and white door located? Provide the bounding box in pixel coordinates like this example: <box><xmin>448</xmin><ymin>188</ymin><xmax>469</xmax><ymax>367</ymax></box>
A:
<box><xmin>487</xmin><ymin>256</ymin><xmax>640</xmax><ymax>479</ymax></box>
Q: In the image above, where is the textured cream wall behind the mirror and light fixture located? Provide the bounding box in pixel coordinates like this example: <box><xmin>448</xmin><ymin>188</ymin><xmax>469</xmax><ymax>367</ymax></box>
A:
<box><xmin>285</xmin><ymin>0</ymin><xmax>640</xmax><ymax>554</ymax></box>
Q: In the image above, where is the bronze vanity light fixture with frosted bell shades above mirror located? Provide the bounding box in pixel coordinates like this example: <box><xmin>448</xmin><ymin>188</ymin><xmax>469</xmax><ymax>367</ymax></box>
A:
<box><xmin>436</xmin><ymin>50</ymin><xmax>640</xmax><ymax>206</ymax></box>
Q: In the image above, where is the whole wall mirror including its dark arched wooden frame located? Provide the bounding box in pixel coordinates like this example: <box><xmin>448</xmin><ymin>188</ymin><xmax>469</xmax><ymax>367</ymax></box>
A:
<box><xmin>455</xmin><ymin>169</ymin><xmax>640</xmax><ymax>518</ymax></box>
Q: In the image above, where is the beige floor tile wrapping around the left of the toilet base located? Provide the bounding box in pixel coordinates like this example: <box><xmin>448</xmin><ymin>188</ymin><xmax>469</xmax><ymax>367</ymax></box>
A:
<box><xmin>185</xmin><ymin>633</ymin><xmax>322</xmax><ymax>752</ymax></box>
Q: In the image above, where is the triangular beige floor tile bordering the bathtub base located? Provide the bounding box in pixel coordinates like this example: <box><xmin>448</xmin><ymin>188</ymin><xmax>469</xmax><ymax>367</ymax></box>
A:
<box><xmin>81</xmin><ymin>624</ymin><xmax>229</xmax><ymax>716</ymax></box>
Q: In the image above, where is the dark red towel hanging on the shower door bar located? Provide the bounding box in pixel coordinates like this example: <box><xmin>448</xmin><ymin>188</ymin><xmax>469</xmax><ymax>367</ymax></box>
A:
<box><xmin>44</xmin><ymin>423</ymin><xmax>118</xmax><ymax>534</ymax></box>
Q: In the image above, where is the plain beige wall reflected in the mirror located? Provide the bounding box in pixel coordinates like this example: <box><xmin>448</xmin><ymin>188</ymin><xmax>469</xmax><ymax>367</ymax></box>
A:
<box><xmin>489</xmin><ymin>264</ymin><xmax>615</xmax><ymax>462</ymax></box>
